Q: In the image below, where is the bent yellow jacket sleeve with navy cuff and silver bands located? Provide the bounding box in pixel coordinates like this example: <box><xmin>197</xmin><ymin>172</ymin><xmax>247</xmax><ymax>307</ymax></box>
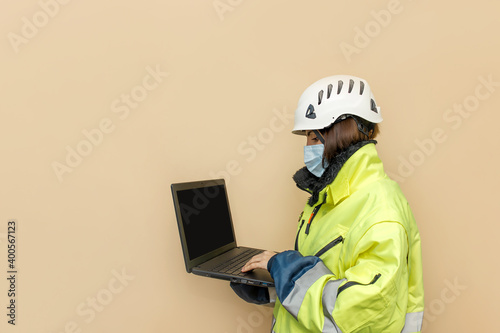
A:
<box><xmin>268</xmin><ymin>222</ymin><xmax>412</xmax><ymax>333</ymax></box>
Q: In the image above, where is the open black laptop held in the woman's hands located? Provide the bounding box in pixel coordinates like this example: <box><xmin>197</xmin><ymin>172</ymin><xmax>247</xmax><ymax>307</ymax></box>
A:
<box><xmin>171</xmin><ymin>179</ymin><xmax>274</xmax><ymax>287</ymax></box>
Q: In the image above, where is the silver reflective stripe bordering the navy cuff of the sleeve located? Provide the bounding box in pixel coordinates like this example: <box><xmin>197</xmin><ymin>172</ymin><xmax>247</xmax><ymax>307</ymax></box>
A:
<box><xmin>281</xmin><ymin>261</ymin><xmax>333</xmax><ymax>319</ymax></box>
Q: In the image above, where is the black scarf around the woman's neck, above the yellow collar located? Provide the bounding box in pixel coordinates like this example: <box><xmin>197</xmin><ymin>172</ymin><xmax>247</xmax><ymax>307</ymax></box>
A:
<box><xmin>293</xmin><ymin>140</ymin><xmax>377</xmax><ymax>206</ymax></box>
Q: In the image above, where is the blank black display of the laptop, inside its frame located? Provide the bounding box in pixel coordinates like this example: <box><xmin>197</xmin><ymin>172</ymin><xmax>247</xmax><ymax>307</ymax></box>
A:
<box><xmin>177</xmin><ymin>185</ymin><xmax>234</xmax><ymax>260</ymax></box>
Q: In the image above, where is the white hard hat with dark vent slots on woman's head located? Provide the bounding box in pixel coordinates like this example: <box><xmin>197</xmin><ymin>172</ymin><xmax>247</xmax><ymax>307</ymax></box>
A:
<box><xmin>292</xmin><ymin>75</ymin><xmax>382</xmax><ymax>135</ymax></box>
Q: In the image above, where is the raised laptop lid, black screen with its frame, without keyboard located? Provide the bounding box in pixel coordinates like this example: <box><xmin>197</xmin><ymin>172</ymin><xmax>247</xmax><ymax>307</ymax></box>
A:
<box><xmin>171</xmin><ymin>179</ymin><xmax>236</xmax><ymax>273</ymax></box>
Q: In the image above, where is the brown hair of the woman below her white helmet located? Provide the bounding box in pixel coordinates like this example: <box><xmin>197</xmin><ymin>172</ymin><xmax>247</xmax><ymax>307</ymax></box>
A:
<box><xmin>320</xmin><ymin>117</ymin><xmax>380</xmax><ymax>161</ymax></box>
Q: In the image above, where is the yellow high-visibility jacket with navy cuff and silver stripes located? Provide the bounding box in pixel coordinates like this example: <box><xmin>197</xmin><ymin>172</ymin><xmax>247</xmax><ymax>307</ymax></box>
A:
<box><xmin>268</xmin><ymin>143</ymin><xmax>424</xmax><ymax>333</ymax></box>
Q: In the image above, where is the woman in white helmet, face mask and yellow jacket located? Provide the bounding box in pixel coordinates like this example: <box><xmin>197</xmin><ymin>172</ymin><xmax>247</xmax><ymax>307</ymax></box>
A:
<box><xmin>232</xmin><ymin>75</ymin><xmax>424</xmax><ymax>333</ymax></box>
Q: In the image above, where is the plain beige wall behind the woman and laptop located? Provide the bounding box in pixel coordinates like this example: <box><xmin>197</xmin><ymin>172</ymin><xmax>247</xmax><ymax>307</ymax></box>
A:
<box><xmin>0</xmin><ymin>0</ymin><xmax>500</xmax><ymax>333</ymax></box>
